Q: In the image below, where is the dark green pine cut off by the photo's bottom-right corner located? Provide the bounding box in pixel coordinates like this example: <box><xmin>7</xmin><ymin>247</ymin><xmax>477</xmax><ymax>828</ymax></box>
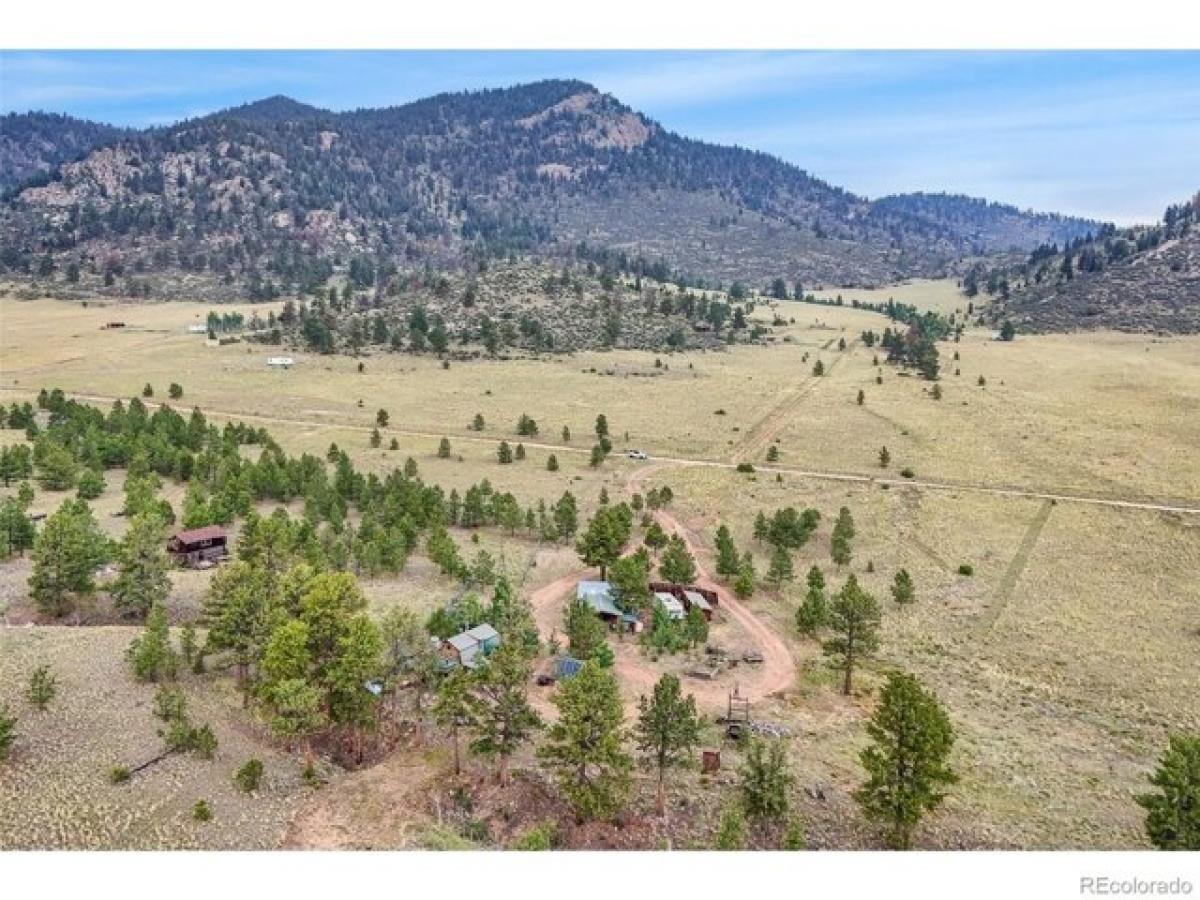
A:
<box><xmin>1138</xmin><ymin>734</ymin><xmax>1200</xmax><ymax>850</ymax></box>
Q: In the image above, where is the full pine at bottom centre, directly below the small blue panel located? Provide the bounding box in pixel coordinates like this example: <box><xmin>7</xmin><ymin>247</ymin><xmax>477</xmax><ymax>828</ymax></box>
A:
<box><xmin>538</xmin><ymin>660</ymin><xmax>634</xmax><ymax>822</ymax></box>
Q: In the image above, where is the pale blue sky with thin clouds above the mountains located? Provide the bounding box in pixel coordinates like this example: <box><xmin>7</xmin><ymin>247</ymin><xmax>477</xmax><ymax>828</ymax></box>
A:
<box><xmin>0</xmin><ymin>50</ymin><xmax>1200</xmax><ymax>223</ymax></box>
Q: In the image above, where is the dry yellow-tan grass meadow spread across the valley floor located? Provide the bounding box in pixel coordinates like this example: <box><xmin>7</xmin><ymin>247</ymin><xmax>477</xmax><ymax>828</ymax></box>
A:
<box><xmin>0</xmin><ymin>282</ymin><xmax>1200</xmax><ymax>848</ymax></box>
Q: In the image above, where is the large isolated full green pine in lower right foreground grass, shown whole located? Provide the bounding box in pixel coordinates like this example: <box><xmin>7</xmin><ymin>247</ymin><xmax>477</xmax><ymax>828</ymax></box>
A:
<box><xmin>854</xmin><ymin>672</ymin><xmax>958</xmax><ymax>850</ymax></box>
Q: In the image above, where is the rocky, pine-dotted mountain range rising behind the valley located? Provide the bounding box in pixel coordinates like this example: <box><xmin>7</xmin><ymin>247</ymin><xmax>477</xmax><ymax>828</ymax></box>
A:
<box><xmin>0</xmin><ymin>80</ymin><xmax>1100</xmax><ymax>290</ymax></box>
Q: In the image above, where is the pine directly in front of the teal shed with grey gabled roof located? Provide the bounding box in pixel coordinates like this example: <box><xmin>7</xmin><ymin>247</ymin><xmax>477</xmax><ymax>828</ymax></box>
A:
<box><xmin>470</xmin><ymin>644</ymin><xmax>541</xmax><ymax>786</ymax></box>
